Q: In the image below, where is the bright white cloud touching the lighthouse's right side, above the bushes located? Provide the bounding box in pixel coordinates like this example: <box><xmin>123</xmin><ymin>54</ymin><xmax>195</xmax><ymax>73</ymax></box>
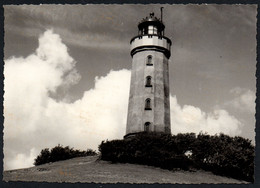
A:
<box><xmin>170</xmin><ymin>96</ymin><xmax>242</xmax><ymax>136</ymax></box>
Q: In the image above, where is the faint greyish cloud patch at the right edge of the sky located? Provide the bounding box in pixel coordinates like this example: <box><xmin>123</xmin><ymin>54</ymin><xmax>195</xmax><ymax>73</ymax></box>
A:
<box><xmin>225</xmin><ymin>87</ymin><xmax>256</xmax><ymax>113</ymax></box>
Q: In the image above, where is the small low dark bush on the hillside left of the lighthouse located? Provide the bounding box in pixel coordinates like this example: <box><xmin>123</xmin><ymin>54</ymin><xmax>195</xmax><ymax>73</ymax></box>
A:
<box><xmin>34</xmin><ymin>144</ymin><xmax>97</xmax><ymax>166</ymax></box>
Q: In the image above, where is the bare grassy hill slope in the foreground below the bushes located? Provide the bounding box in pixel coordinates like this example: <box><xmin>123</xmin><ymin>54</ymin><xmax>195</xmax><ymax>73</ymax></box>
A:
<box><xmin>3</xmin><ymin>156</ymin><xmax>248</xmax><ymax>184</ymax></box>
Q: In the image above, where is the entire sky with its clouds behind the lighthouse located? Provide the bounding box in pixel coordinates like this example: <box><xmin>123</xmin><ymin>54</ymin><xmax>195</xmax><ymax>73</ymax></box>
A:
<box><xmin>4</xmin><ymin>4</ymin><xmax>257</xmax><ymax>170</ymax></box>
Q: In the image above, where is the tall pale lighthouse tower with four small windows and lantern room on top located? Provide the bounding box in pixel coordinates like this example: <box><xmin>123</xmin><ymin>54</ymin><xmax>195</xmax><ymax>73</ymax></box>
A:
<box><xmin>124</xmin><ymin>13</ymin><xmax>171</xmax><ymax>138</ymax></box>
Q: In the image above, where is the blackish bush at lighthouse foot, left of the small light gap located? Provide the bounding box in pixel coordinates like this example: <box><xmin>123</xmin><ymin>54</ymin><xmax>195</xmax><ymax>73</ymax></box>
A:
<box><xmin>99</xmin><ymin>133</ymin><xmax>192</xmax><ymax>170</ymax></box>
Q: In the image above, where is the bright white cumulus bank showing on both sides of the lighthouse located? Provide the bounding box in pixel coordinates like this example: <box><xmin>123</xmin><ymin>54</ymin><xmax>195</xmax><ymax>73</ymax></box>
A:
<box><xmin>4</xmin><ymin>30</ymin><xmax>244</xmax><ymax>170</ymax></box>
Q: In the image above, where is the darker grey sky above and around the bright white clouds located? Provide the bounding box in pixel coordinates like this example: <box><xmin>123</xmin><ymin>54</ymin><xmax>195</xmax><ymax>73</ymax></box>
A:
<box><xmin>4</xmin><ymin>4</ymin><xmax>257</xmax><ymax>169</ymax></box>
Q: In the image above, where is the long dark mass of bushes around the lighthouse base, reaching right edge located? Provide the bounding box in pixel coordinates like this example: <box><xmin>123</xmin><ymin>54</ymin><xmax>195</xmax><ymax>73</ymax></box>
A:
<box><xmin>99</xmin><ymin>133</ymin><xmax>254</xmax><ymax>182</ymax></box>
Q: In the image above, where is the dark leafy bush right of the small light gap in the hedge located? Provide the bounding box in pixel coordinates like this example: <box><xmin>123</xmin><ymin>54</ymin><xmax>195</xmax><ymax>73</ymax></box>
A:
<box><xmin>192</xmin><ymin>134</ymin><xmax>254</xmax><ymax>182</ymax></box>
